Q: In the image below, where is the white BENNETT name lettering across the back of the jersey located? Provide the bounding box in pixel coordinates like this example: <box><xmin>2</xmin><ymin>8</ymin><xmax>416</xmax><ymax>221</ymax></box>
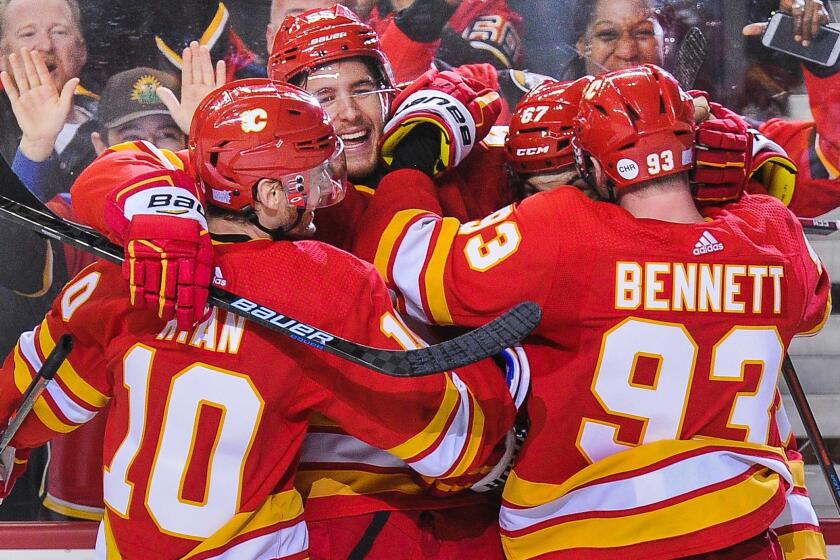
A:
<box><xmin>614</xmin><ymin>261</ymin><xmax>785</xmax><ymax>315</ymax></box>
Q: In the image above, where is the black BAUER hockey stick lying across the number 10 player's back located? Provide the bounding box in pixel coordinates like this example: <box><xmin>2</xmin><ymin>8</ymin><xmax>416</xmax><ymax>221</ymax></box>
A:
<box><xmin>0</xmin><ymin>157</ymin><xmax>542</xmax><ymax>377</ymax></box>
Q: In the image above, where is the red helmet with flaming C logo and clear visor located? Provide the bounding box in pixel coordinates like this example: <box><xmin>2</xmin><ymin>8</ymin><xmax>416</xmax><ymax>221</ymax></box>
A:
<box><xmin>189</xmin><ymin>78</ymin><xmax>346</xmax><ymax>215</ymax></box>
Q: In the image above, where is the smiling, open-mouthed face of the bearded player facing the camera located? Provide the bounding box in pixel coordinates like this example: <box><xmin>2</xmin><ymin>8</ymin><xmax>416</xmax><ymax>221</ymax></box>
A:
<box><xmin>306</xmin><ymin>59</ymin><xmax>385</xmax><ymax>180</ymax></box>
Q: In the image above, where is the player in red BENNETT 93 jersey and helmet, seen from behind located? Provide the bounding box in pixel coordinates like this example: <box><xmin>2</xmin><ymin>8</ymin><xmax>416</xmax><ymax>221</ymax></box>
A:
<box><xmin>350</xmin><ymin>66</ymin><xmax>830</xmax><ymax>559</ymax></box>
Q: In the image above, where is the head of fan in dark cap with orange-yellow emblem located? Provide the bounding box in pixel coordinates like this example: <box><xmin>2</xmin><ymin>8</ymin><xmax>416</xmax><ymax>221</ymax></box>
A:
<box><xmin>90</xmin><ymin>67</ymin><xmax>186</xmax><ymax>154</ymax></box>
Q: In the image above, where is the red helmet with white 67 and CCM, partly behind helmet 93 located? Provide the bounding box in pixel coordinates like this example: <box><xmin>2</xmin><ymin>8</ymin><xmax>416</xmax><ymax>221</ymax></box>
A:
<box><xmin>505</xmin><ymin>76</ymin><xmax>593</xmax><ymax>173</ymax></box>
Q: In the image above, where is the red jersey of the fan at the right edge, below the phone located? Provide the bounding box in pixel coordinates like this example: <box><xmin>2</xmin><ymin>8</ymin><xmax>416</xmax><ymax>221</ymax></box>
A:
<box><xmin>759</xmin><ymin>63</ymin><xmax>840</xmax><ymax>217</ymax></box>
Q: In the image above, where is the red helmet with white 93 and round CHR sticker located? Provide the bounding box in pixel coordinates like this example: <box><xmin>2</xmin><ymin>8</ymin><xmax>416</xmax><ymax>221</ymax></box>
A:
<box><xmin>574</xmin><ymin>64</ymin><xmax>694</xmax><ymax>195</ymax></box>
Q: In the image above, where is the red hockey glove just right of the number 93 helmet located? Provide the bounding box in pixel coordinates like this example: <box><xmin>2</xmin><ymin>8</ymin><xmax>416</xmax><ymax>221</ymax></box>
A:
<box><xmin>692</xmin><ymin>103</ymin><xmax>753</xmax><ymax>202</ymax></box>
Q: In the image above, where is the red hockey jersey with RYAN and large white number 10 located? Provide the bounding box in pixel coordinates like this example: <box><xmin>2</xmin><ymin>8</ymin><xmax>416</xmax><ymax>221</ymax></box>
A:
<box><xmin>0</xmin><ymin>232</ymin><xmax>513</xmax><ymax>559</ymax></box>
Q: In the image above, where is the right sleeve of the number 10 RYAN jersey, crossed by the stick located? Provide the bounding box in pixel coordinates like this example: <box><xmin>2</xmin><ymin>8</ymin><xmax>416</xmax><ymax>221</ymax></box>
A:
<box><xmin>213</xmin><ymin>242</ymin><xmax>515</xmax><ymax>477</ymax></box>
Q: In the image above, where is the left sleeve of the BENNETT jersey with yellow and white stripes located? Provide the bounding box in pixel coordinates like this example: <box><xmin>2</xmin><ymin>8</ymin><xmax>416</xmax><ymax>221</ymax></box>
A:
<box><xmin>356</xmin><ymin>170</ymin><xmax>560</xmax><ymax>326</ymax></box>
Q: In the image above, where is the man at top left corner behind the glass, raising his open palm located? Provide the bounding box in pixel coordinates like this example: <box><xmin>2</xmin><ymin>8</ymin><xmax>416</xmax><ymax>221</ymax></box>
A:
<box><xmin>0</xmin><ymin>0</ymin><xmax>96</xmax><ymax>201</ymax></box>
